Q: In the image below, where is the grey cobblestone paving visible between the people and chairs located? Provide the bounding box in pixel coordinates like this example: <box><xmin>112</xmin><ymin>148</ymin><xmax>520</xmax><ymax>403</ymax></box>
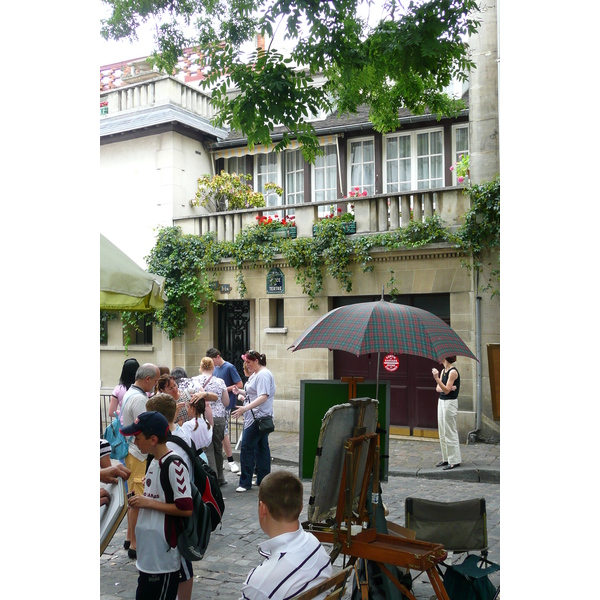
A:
<box><xmin>100</xmin><ymin>432</ymin><xmax>500</xmax><ymax>600</ymax></box>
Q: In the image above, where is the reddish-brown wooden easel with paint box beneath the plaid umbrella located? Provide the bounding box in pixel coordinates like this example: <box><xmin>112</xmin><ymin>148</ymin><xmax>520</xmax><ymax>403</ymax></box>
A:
<box><xmin>303</xmin><ymin>405</ymin><xmax>450</xmax><ymax>600</ymax></box>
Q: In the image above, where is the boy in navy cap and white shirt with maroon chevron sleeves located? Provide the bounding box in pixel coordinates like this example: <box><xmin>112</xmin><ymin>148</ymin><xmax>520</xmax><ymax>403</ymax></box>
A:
<box><xmin>121</xmin><ymin>411</ymin><xmax>193</xmax><ymax>600</ymax></box>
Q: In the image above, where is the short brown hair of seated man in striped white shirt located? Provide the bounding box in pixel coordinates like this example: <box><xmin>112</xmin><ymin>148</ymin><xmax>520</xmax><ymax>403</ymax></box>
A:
<box><xmin>258</xmin><ymin>470</ymin><xmax>304</xmax><ymax>523</ymax></box>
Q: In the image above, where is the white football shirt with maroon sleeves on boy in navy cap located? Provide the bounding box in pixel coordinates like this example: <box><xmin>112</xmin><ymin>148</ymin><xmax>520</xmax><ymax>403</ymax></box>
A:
<box><xmin>135</xmin><ymin>452</ymin><xmax>192</xmax><ymax>573</ymax></box>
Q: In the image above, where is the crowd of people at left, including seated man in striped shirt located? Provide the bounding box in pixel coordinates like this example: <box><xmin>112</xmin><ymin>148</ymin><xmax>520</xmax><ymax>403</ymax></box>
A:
<box><xmin>100</xmin><ymin>348</ymin><xmax>331</xmax><ymax>600</ymax></box>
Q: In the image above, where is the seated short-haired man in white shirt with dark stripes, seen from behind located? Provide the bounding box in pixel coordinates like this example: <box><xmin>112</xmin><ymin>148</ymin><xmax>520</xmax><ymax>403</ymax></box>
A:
<box><xmin>241</xmin><ymin>471</ymin><xmax>332</xmax><ymax>600</ymax></box>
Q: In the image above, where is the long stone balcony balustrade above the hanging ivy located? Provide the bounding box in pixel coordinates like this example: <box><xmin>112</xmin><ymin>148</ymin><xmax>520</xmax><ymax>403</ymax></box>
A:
<box><xmin>174</xmin><ymin>186</ymin><xmax>469</xmax><ymax>242</ymax></box>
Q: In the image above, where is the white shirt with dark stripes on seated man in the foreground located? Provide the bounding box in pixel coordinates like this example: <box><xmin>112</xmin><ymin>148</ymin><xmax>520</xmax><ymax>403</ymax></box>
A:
<box><xmin>241</xmin><ymin>525</ymin><xmax>332</xmax><ymax>600</ymax></box>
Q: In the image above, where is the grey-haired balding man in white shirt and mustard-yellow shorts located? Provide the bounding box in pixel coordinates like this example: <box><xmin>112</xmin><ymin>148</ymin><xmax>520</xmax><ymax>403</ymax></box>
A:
<box><xmin>121</xmin><ymin>363</ymin><xmax>160</xmax><ymax>558</ymax></box>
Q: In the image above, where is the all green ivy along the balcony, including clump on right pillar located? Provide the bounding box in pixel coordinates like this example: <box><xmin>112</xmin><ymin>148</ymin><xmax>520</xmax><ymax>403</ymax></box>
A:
<box><xmin>105</xmin><ymin>178</ymin><xmax>500</xmax><ymax>340</ymax></box>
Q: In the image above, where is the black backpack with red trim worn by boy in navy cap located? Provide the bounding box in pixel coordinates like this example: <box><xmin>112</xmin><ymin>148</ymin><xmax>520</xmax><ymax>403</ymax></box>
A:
<box><xmin>160</xmin><ymin>452</ymin><xmax>211</xmax><ymax>561</ymax></box>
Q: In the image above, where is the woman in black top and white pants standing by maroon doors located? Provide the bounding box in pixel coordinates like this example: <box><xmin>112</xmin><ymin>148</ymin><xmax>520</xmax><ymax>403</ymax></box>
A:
<box><xmin>431</xmin><ymin>356</ymin><xmax>461</xmax><ymax>471</ymax></box>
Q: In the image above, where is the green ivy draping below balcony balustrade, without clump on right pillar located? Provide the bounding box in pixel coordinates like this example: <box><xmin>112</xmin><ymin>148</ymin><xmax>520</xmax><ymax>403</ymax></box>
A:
<box><xmin>146</xmin><ymin>216</ymin><xmax>450</xmax><ymax>339</ymax></box>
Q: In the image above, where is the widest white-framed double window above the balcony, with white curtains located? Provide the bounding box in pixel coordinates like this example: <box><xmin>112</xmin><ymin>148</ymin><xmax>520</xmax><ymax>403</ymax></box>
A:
<box><xmin>384</xmin><ymin>129</ymin><xmax>444</xmax><ymax>192</ymax></box>
